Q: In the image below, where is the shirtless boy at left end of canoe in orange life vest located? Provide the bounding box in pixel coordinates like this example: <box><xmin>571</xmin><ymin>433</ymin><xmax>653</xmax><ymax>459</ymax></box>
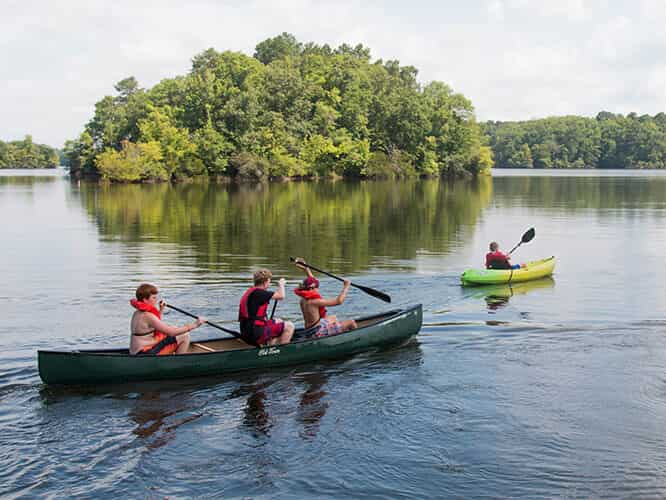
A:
<box><xmin>130</xmin><ymin>283</ymin><xmax>206</xmax><ymax>356</ymax></box>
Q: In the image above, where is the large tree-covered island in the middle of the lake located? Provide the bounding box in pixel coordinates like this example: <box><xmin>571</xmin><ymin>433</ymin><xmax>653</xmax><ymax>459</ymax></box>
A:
<box><xmin>65</xmin><ymin>33</ymin><xmax>492</xmax><ymax>182</ymax></box>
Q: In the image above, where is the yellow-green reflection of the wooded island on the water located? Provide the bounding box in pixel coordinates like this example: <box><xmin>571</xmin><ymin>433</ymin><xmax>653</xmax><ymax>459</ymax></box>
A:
<box><xmin>73</xmin><ymin>178</ymin><xmax>492</xmax><ymax>271</ymax></box>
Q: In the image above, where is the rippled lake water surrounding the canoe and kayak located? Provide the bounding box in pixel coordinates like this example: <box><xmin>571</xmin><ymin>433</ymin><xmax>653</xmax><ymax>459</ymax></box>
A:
<box><xmin>0</xmin><ymin>171</ymin><xmax>666</xmax><ymax>498</ymax></box>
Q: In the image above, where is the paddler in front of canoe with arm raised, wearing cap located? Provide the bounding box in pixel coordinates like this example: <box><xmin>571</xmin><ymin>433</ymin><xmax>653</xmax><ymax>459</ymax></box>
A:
<box><xmin>294</xmin><ymin>258</ymin><xmax>358</xmax><ymax>337</ymax></box>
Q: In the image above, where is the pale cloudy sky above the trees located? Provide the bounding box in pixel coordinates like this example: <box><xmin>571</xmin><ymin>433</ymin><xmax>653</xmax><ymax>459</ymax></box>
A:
<box><xmin>0</xmin><ymin>0</ymin><xmax>666</xmax><ymax>147</ymax></box>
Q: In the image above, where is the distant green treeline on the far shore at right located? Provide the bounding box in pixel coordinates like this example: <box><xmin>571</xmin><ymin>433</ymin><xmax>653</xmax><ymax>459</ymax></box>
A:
<box><xmin>483</xmin><ymin>111</ymin><xmax>666</xmax><ymax>168</ymax></box>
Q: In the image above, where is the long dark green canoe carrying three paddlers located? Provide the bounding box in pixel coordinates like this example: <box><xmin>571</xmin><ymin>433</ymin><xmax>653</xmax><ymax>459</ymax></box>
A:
<box><xmin>37</xmin><ymin>304</ymin><xmax>423</xmax><ymax>384</ymax></box>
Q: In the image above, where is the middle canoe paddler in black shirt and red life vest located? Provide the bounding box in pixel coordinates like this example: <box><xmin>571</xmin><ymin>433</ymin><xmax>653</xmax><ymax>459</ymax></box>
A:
<box><xmin>238</xmin><ymin>269</ymin><xmax>294</xmax><ymax>347</ymax></box>
